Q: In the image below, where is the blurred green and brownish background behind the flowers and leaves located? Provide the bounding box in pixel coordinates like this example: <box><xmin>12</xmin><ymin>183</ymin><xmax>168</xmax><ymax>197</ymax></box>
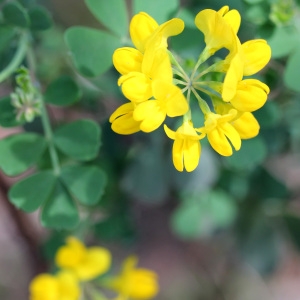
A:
<box><xmin>0</xmin><ymin>0</ymin><xmax>300</xmax><ymax>300</ymax></box>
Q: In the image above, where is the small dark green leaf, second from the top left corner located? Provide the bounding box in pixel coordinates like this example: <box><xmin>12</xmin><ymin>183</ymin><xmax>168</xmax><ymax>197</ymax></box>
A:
<box><xmin>28</xmin><ymin>6</ymin><xmax>52</xmax><ymax>30</ymax></box>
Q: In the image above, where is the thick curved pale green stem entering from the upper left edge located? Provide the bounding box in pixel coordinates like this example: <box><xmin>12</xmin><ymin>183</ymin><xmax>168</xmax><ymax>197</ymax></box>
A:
<box><xmin>0</xmin><ymin>32</ymin><xmax>29</xmax><ymax>82</ymax></box>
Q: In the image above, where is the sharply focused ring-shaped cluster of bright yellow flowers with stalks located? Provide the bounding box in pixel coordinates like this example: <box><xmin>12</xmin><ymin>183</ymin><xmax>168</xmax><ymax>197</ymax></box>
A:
<box><xmin>110</xmin><ymin>6</ymin><xmax>271</xmax><ymax>172</ymax></box>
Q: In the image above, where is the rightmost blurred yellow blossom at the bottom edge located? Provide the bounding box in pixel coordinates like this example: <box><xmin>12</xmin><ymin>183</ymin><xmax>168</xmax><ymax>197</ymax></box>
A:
<box><xmin>107</xmin><ymin>256</ymin><xmax>159</xmax><ymax>300</ymax></box>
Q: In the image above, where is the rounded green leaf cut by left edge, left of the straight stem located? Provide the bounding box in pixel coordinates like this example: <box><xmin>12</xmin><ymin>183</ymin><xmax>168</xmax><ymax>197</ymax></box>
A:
<box><xmin>0</xmin><ymin>133</ymin><xmax>47</xmax><ymax>176</ymax></box>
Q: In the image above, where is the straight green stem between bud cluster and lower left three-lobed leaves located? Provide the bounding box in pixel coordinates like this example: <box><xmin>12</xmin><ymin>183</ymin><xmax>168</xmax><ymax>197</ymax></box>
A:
<box><xmin>41</xmin><ymin>99</ymin><xmax>60</xmax><ymax>176</ymax></box>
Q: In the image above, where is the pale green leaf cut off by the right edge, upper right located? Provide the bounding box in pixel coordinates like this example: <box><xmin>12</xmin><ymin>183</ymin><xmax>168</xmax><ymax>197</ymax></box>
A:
<box><xmin>283</xmin><ymin>47</ymin><xmax>300</xmax><ymax>93</ymax></box>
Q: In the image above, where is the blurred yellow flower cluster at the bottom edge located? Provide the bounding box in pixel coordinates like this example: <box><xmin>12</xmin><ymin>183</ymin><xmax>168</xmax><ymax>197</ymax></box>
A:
<box><xmin>29</xmin><ymin>237</ymin><xmax>159</xmax><ymax>300</ymax></box>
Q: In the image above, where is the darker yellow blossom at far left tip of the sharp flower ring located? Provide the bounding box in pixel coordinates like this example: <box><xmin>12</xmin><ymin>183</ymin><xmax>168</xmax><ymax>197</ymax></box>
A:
<box><xmin>109</xmin><ymin>102</ymin><xmax>141</xmax><ymax>135</ymax></box>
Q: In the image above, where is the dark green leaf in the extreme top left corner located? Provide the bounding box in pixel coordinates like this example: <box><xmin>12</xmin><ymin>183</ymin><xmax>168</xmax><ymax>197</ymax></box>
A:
<box><xmin>2</xmin><ymin>1</ymin><xmax>29</xmax><ymax>27</ymax></box>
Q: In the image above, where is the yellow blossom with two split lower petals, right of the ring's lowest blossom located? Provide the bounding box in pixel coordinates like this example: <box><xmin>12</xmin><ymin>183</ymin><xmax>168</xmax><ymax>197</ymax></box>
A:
<box><xmin>202</xmin><ymin>109</ymin><xmax>241</xmax><ymax>156</ymax></box>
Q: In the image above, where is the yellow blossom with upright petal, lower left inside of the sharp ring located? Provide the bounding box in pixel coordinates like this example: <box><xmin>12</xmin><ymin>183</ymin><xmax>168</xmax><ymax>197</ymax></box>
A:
<box><xmin>133</xmin><ymin>80</ymin><xmax>189</xmax><ymax>132</ymax></box>
